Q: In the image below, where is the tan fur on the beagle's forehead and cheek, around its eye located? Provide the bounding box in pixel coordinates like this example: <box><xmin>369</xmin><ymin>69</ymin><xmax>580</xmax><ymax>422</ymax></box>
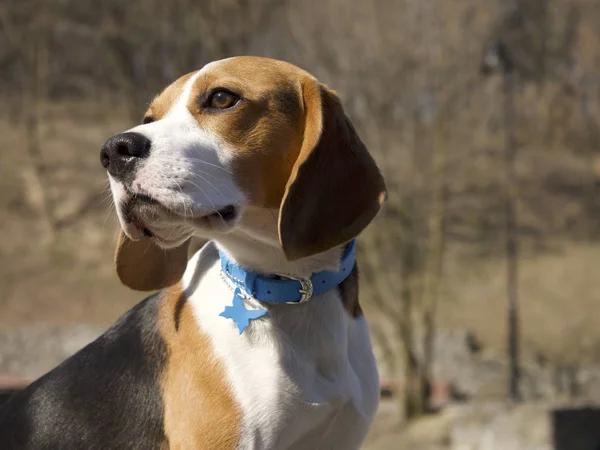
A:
<box><xmin>188</xmin><ymin>57</ymin><xmax>307</xmax><ymax>208</ymax></box>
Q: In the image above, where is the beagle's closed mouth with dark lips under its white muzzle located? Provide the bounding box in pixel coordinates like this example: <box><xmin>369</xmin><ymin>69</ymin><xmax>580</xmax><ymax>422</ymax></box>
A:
<box><xmin>121</xmin><ymin>194</ymin><xmax>239</xmax><ymax>245</ymax></box>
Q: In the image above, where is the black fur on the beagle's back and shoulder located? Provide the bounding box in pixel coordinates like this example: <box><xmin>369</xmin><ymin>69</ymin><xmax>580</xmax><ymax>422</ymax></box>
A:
<box><xmin>0</xmin><ymin>293</ymin><xmax>166</xmax><ymax>450</ymax></box>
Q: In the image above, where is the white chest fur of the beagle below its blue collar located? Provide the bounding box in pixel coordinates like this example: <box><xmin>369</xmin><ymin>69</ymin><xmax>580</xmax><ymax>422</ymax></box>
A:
<box><xmin>184</xmin><ymin>243</ymin><xmax>379</xmax><ymax>450</ymax></box>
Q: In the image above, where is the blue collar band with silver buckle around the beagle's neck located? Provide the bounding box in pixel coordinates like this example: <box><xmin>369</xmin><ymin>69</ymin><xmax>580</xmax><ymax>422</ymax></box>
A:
<box><xmin>219</xmin><ymin>240</ymin><xmax>356</xmax><ymax>305</ymax></box>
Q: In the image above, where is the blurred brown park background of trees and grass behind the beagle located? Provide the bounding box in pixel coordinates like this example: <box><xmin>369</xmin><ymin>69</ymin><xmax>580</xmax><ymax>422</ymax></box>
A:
<box><xmin>0</xmin><ymin>0</ymin><xmax>600</xmax><ymax>450</ymax></box>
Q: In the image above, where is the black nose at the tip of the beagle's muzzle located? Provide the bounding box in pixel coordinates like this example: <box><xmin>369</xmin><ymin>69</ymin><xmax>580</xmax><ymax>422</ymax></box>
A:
<box><xmin>100</xmin><ymin>133</ymin><xmax>151</xmax><ymax>179</ymax></box>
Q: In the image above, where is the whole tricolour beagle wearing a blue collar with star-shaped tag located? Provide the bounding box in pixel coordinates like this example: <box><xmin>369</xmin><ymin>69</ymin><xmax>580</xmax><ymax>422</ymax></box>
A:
<box><xmin>0</xmin><ymin>57</ymin><xmax>386</xmax><ymax>450</ymax></box>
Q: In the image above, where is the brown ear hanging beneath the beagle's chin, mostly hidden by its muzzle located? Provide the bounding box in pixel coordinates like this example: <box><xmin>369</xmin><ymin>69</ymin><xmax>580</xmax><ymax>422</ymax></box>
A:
<box><xmin>115</xmin><ymin>231</ymin><xmax>190</xmax><ymax>291</ymax></box>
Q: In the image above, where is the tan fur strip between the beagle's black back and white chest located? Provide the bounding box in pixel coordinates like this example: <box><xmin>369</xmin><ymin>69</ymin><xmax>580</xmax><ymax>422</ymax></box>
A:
<box><xmin>159</xmin><ymin>285</ymin><xmax>242</xmax><ymax>450</ymax></box>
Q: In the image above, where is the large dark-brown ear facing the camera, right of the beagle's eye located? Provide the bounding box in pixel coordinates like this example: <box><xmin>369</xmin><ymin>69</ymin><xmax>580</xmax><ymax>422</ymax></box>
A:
<box><xmin>279</xmin><ymin>77</ymin><xmax>386</xmax><ymax>260</ymax></box>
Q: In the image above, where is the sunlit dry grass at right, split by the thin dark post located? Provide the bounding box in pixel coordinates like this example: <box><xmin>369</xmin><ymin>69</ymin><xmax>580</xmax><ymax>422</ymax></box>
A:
<box><xmin>440</xmin><ymin>242</ymin><xmax>600</xmax><ymax>363</ymax></box>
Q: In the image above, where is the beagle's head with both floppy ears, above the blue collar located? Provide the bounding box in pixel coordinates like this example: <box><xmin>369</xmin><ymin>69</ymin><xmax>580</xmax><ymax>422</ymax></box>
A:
<box><xmin>100</xmin><ymin>57</ymin><xmax>385</xmax><ymax>290</ymax></box>
